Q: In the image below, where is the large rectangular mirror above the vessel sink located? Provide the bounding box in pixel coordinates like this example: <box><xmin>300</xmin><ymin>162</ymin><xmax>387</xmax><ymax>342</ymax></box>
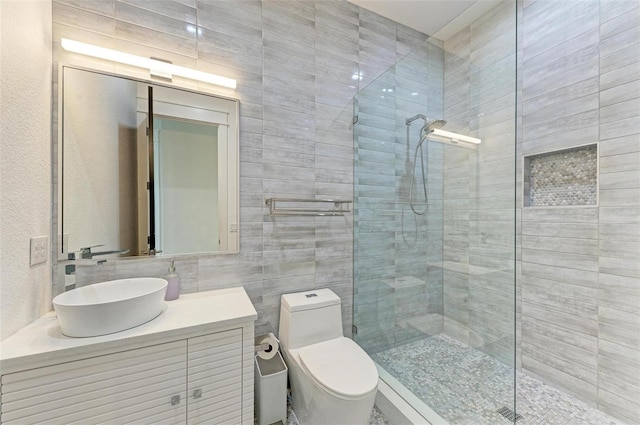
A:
<box><xmin>58</xmin><ymin>66</ymin><xmax>239</xmax><ymax>258</ymax></box>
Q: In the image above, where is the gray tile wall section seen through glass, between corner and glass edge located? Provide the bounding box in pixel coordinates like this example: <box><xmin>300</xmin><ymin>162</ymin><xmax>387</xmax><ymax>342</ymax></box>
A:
<box><xmin>443</xmin><ymin>1</ymin><xmax>516</xmax><ymax>364</ymax></box>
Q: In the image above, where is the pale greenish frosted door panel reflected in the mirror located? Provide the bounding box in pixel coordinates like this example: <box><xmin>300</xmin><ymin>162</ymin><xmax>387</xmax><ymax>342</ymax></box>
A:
<box><xmin>153</xmin><ymin>116</ymin><xmax>220</xmax><ymax>254</ymax></box>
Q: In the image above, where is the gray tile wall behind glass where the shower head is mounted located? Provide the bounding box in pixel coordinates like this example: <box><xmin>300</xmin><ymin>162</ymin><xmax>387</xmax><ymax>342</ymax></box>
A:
<box><xmin>354</xmin><ymin>38</ymin><xmax>444</xmax><ymax>352</ymax></box>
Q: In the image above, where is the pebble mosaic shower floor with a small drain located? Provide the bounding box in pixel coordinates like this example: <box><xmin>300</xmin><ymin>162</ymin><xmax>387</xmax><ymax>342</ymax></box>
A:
<box><xmin>371</xmin><ymin>335</ymin><xmax>626</xmax><ymax>425</ymax></box>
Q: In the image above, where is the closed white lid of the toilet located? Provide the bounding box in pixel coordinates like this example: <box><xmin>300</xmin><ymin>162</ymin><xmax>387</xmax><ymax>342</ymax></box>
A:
<box><xmin>299</xmin><ymin>337</ymin><xmax>378</xmax><ymax>399</ymax></box>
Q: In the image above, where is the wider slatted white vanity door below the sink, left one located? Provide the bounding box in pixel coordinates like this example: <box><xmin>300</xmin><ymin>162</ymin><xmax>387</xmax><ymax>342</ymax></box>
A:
<box><xmin>1</xmin><ymin>340</ymin><xmax>187</xmax><ymax>425</ymax></box>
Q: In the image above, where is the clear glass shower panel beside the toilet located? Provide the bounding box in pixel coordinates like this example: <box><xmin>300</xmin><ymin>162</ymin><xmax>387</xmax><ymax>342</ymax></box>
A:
<box><xmin>353</xmin><ymin>1</ymin><xmax>516</xmax><ymax>425</ymax></box>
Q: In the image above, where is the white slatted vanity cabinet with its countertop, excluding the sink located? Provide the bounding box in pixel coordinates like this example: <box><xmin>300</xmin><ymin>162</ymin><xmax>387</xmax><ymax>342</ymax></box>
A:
<box><xmin>0</xmin><ymin>288</ymin><xmax>257</xmax><ymax>425</ymax></box>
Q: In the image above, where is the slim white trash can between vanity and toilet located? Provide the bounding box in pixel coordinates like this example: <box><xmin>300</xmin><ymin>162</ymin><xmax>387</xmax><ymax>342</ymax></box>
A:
<box><xmin>254</xmin><ymin>351</ymin><xmax>287</xmax><ymax>425</ymax></box>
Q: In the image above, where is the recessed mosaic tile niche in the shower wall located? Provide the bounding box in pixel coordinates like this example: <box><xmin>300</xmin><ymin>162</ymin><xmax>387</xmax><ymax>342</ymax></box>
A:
<box><xmin>524</xmin><ymin>145</ymin><xmax>598</xmax><ymax>207</ymax></box>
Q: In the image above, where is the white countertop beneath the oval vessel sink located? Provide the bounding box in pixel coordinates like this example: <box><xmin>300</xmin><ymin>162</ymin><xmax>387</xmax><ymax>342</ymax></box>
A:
<box><xmin>0</xmin><ymin>287</ymin><xmax>258</xmax><ymax>373</ymax></box>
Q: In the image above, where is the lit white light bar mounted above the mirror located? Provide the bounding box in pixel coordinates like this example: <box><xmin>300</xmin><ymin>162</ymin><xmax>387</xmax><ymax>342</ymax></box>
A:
<box><xmin>62</xmin><ymin>38</ymin><xmax>236</xmax><ymax>89</ymax></box>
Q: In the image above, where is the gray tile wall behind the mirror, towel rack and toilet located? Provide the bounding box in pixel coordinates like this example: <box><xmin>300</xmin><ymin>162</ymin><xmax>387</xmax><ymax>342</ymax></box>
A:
<box><xmin>53</xmin><ymin>0</ymin><xmax>425</xmax><ymax>335</ymax></box>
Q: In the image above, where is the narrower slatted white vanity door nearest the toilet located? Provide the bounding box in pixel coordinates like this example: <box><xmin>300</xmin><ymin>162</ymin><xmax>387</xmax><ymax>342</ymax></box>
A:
<box><xmin>187</xmin><ymin>329</ymin><xmax>242</xmax><ymax>425</ymax></box>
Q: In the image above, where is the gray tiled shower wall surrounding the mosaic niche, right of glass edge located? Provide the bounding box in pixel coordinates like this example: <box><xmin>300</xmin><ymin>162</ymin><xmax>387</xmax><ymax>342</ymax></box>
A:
<box><xmin>519</xmin><ymin>0</ymin><xmax>640</xmax><ymax>424</ymax></box>
